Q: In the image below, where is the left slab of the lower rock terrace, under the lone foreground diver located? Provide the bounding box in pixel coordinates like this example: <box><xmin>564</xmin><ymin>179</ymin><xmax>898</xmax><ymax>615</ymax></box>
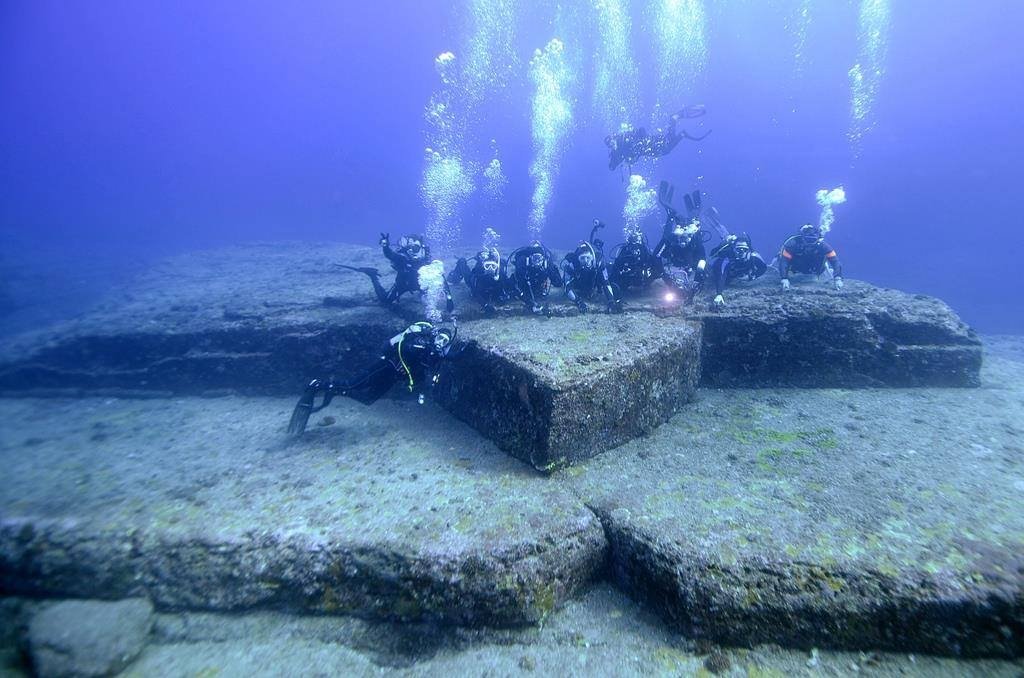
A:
<box><xmin>0</xmin><ymin>397</ymin><xmax>605</xmax><ymax>625</ymax></box>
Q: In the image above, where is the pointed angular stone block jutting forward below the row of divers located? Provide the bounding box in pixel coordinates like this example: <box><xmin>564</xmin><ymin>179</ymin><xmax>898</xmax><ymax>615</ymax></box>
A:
<box><xmin>440</xmin><ymin>313</ymin><xmax>700</xmax><ymax>470</ymax></box>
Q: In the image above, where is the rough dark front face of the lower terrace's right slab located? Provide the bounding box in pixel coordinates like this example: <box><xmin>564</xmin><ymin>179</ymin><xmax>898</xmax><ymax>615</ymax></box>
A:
<box><xmin>601</xmin><ymin>513</ymin><xmax>1024</xmax><ymax>658</ymax></box>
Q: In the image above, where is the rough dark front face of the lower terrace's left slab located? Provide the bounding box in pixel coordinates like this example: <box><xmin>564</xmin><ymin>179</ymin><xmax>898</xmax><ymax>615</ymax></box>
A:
<box><xmin>0</xmin><ymin>512</ymin><xmax>607</xmax><ymax>627</ymax></box>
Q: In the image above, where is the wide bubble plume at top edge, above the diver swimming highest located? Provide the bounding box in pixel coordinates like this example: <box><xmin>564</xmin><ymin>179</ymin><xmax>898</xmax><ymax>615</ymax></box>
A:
<box><xmin>649</xmin><ymin>0</ymin><xmax>708</xmax><ymax>115</ymax></box>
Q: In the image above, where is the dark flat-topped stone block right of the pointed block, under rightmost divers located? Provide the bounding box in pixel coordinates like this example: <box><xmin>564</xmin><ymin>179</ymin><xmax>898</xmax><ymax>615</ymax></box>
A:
<box><xmin>693</xmin><ymin>280</ymin><xmax>982</xmax><ymax>388</ymax></box>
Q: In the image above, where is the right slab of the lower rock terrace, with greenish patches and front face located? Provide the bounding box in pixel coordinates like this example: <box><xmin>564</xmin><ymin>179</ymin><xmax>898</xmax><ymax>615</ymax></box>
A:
<box><xmin>560</xmin><ymin>340</ymin><xmax>1024</xmax><ymax>654</ymax></box>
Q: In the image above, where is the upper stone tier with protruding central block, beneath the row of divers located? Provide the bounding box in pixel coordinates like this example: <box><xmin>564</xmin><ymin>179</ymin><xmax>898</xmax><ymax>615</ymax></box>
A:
<box><xmin>0</xmin><ymin>243</ymin><xmax>981</xmax><ymax>469</ymax></box>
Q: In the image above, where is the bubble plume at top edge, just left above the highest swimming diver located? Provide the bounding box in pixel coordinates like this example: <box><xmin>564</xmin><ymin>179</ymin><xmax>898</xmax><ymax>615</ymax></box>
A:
<box><xmin>594</xmin><ymin>0</ymin><xmax>640</xmax><ymax>133</ymax></box>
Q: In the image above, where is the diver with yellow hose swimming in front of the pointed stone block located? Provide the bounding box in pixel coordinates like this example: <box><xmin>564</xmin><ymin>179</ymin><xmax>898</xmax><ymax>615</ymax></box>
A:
<box><xmin>288</xmin><ymin>323</ymin><xmax>465</xmax><ymax>435</ymax></box>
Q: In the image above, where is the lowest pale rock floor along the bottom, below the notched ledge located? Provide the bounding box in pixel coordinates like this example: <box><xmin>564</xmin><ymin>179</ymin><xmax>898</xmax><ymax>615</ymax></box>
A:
<box><xmin>8</xmin><ymin>585</ymin><xmax>1024</xmax><ymax>678</ymax></box>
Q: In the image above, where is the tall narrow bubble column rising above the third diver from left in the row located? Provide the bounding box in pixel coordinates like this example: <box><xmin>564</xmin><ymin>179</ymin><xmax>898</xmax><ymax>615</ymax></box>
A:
<box><xmin>528</xmin><ymin>38</ymin><xmax>573</xmax><ymax>238</ymax></box>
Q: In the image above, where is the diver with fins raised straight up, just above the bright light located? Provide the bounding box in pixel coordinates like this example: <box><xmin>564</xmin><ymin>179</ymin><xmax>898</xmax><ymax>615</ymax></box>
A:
<box><xmin>654</xmin><ymin>181</ymin><xmax>711</xmax><ymax>303</ymax></box>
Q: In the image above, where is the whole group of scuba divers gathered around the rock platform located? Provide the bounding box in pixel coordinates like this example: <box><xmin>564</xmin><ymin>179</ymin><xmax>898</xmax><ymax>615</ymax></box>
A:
<box><xmin>288</xmin><ymin>107</ymin><xmax>843</xmax><ymax>435</ymax></box>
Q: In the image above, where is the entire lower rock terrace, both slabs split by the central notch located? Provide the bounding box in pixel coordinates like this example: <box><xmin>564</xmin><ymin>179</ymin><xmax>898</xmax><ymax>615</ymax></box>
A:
<box><xmin>0</xmin><ymin>339</ymin><xmax>1024</xmax><ymax>659</ymax></box>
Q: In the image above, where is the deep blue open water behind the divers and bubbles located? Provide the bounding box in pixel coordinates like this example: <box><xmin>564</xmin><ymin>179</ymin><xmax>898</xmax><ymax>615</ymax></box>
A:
<box><xmin>0</xmin><ymin>0</ymin><xmax>1024</xmax><ymax>333</ymax></box>
